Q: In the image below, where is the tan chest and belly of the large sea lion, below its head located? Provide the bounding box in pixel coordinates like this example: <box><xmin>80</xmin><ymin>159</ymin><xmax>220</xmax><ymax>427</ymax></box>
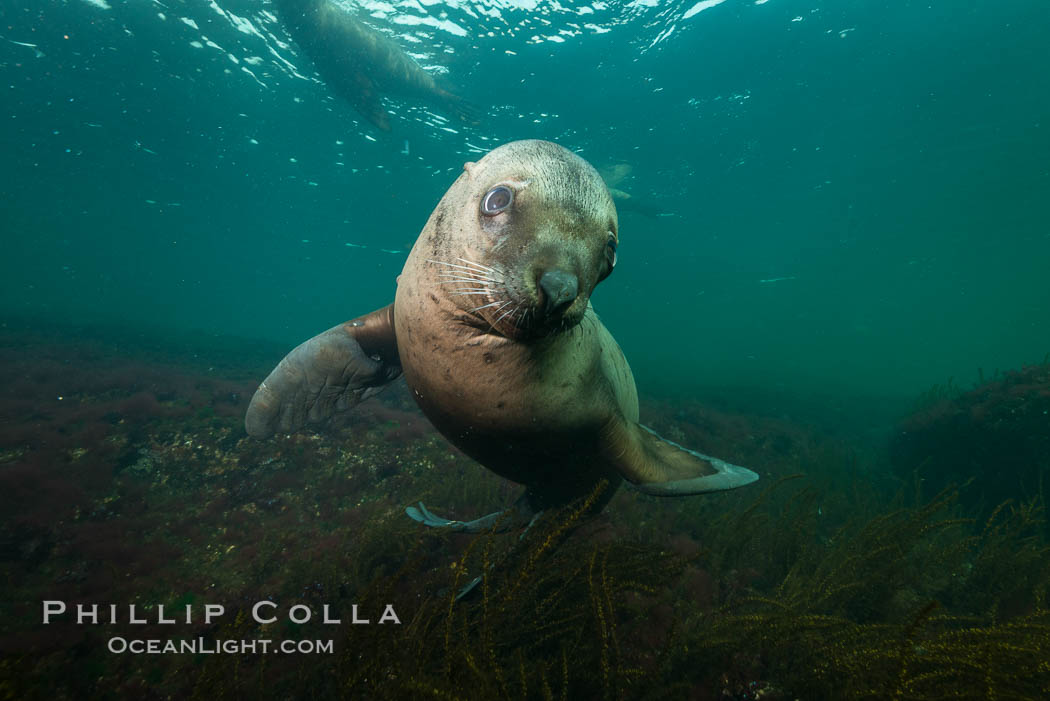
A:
<box><xmin>395</xmin><ymin>305</ymin><xmax>638</xmax><ymax>502</ymax></box>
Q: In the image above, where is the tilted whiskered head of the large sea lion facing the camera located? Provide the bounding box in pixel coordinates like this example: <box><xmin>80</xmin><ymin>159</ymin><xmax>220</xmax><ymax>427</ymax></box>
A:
<box><xmin>425</xmin><ymin>141</ymin><xmax>618</xmax><ymax>340</ymax></box>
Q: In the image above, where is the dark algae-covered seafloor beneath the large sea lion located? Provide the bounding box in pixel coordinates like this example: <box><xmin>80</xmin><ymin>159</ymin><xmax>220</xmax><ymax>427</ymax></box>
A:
<box><xmin>0</xmin><ymin>321</ymin><xmax>1050</xmax><ymax>700</ymax></box>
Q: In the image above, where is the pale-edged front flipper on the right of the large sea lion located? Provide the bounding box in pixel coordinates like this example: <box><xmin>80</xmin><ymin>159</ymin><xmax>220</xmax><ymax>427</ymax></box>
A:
<box><xmin>605</xmin><ymin>418</ymin><xmax>758</xmax><ymax>496</ymax></box>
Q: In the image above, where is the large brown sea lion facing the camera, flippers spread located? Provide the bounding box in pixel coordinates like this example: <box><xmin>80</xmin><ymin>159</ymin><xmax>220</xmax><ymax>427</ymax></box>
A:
<box><xmin>246</xmin><ymin>141</ymin><xmax>758</xmax><ymax>530</ymax></box>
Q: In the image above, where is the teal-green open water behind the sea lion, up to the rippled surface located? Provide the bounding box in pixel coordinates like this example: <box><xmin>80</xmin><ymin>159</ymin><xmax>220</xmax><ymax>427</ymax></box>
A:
<box><xmin>0</xmin><ymin>0</ymin><xmax>1050</xmax><ymax>395</ymax></box>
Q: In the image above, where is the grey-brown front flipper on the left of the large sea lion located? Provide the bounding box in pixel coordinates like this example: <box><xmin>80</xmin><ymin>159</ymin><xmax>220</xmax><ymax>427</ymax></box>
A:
<box><xmin>245</xmin><ymin>304</ymin><xmax>401</xmax><ymax>438</ymax></box>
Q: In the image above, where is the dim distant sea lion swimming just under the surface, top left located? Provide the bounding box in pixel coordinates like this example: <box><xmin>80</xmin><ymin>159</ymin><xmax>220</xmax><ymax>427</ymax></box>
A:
<box><xmin>274</xmin><ymin>0</ymin><xmax>477</xmax><ymax>131</ymax></box>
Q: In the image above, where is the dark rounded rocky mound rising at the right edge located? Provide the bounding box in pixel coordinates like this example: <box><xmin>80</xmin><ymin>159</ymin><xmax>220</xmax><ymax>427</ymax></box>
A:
<box><xmin>890</xmin><ymin>363</ymin><xmax>1050</xmax><ymax>509</ymax></box>
